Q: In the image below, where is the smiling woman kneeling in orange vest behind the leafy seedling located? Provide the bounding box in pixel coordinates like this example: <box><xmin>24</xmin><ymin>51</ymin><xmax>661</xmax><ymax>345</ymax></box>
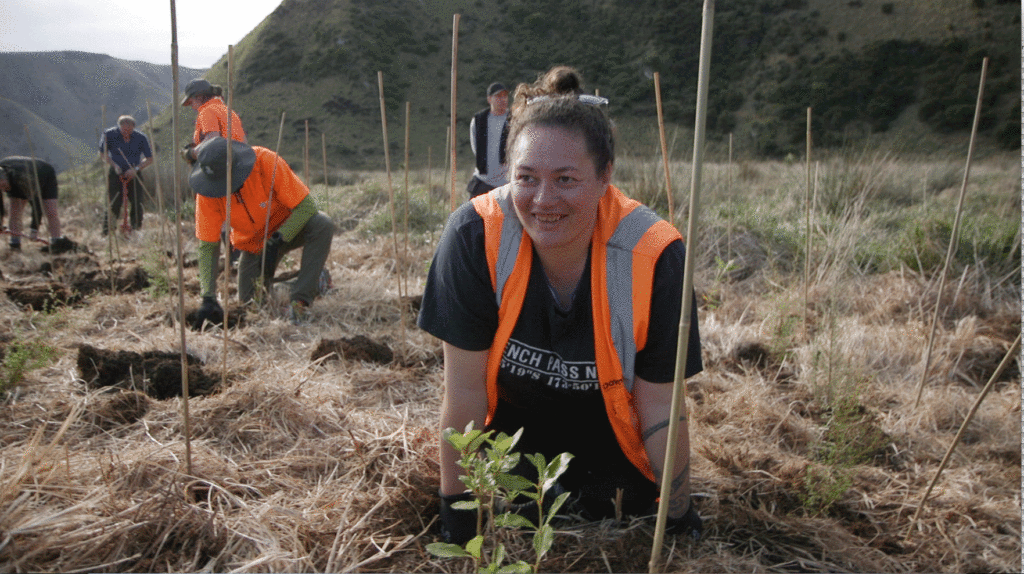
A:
<box><xmin>419</xmin><ymin>67</ymin><xmax>702</xmax><ymax>543</ymax></box>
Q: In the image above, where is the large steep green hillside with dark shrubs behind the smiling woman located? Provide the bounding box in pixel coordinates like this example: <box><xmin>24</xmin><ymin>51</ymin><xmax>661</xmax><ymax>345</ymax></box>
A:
<box><xmin>148</xmin><ymin>0</ymin><xmax>1020</xmax><ymax>175</ymax></box>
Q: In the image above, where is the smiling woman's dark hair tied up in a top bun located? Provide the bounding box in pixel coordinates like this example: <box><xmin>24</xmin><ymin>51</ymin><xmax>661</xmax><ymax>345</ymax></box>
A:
<box><xmin>507</xmin><ymin>65</ymin><xmax>615</xmax><ymax>176</ymax></box>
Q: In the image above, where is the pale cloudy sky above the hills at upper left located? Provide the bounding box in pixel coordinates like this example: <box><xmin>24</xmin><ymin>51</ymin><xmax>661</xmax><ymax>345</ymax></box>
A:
<box><xmin>0</xmin><ymin>0</ymin><xmax>282</xmax><ymax>69</ymax></box>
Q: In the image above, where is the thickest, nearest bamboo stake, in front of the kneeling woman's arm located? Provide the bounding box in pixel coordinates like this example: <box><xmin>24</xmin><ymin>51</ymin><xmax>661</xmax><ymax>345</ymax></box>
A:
<box><xmin>648</xmin><ymin>0</ymin><xmax>715</xmax><ymax>573</ymax></box>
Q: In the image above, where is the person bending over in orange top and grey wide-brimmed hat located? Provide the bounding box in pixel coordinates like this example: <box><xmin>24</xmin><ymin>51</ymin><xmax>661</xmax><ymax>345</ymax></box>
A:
<box><xmin>188</xmin><ymin>136</ymin><xmax>335</xmax><ymax>324</ymax></box>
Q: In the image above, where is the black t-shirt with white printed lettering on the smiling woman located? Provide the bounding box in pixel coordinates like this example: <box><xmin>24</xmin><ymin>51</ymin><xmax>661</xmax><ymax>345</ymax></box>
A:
<box><xmin>419</xmin><ymin>204</ymin><xmax>702</xmax><ymax>493</ymax></box>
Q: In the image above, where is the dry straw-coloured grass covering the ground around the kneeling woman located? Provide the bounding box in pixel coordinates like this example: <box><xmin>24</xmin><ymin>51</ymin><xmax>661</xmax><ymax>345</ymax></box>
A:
<box><xmin>0</xmin><ymin>154</ymin><xmax>1021</xmax><ymax>572</ymax></box>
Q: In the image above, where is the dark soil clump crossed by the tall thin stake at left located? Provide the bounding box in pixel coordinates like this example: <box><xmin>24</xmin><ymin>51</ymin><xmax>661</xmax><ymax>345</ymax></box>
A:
<box><xmin>77</xmin><ymin>345</ymin><xmax>220</xmax><ymax>400</ymax></box>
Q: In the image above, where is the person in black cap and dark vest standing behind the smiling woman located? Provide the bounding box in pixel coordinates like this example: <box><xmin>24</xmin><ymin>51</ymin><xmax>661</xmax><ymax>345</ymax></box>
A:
<box><xmin>466</xmin><ymin>82</ymin><xmax>509</xmax><ymax>198</ymax></box>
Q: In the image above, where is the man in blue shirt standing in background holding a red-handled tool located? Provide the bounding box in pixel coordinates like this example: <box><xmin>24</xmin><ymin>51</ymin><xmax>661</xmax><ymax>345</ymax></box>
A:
<box><xmin>99</xmin><ymin>116</ymin><xmax>153</xmax><ymax>235</ymax></box>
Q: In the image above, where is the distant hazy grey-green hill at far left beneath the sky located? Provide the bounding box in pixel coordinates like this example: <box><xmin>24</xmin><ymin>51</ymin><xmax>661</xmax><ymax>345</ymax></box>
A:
<box><xmin>0</xmin><ymin>51</ymin><xmax>202</xmax><ymax>170</ymax></box>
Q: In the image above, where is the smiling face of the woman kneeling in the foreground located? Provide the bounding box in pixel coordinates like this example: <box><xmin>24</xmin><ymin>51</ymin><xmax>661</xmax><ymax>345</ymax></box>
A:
<box><xmin>510</xmin><ymin>125</ymin><xmax>611</xmax><ymax>257</ymax></box>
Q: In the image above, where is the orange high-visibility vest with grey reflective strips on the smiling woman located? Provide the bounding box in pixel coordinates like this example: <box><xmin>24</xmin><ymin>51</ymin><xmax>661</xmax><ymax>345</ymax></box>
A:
<box><xmin>473</xmin><ymin>185</ymin><xmax>681</xmax><ymax>482</ymax></box>
